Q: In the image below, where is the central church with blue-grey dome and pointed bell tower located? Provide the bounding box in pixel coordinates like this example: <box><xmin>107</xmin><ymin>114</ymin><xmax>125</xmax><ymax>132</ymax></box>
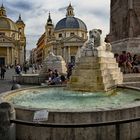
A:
<box><xmin>37</xmin><ymin>4</ymin><xmax>88</xmax><ymax>64</ymax></box>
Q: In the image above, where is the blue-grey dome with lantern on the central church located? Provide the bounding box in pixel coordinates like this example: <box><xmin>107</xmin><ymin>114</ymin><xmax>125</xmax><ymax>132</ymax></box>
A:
<box><xmin>55</xmin><ymin>4</ymin><xmax>87</xmax><ymax>31</ymax></box>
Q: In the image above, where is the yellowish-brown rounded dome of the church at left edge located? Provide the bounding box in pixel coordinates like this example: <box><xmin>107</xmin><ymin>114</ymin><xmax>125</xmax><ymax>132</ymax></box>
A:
<box><xmin>0</xmin><ymin>17</ymin><xmax>18</xmax><ymax>31</ymax></box>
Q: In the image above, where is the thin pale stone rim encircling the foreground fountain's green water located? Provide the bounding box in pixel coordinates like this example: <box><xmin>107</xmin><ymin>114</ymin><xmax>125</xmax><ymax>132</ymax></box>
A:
<box><xmin>0</xmin><ymin>84</ymin><xmax>140</xmax><ymax>113</ymax></box>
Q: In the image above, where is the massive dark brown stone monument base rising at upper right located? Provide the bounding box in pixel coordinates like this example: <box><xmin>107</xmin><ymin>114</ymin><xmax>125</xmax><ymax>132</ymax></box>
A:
<box><xmin>108</xmin><ymin>0</ymin><xmax>140</xmax><ymax>54</ymax></box>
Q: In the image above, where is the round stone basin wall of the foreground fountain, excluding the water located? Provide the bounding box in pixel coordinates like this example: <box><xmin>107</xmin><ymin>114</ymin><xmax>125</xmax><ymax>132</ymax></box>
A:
<box><xmin>1</xmin><ymin>87</ymin><xmax>140</xmax><ymax>140</ymax></box>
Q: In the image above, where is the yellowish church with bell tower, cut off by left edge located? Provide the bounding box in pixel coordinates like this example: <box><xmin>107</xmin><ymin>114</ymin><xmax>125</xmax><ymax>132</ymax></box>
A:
<box><xmin>0</xmin><ymin>4</ymin><xmax>26</xmax><ymax>65</ymax></box>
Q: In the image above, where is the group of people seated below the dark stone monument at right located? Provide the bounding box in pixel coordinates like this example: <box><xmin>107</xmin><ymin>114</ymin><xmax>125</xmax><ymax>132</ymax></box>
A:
<box><xmin>114</xmin><ymin>51</ymin><xmax>140</xmax><ymax>73</ymax></box>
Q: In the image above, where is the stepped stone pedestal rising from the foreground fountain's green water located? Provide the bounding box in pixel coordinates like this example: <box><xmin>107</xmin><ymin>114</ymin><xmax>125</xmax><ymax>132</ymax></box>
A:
<box><xmin>68</xmin><ymin>31</ymin><xmax>123</xmax><ymax>91</ymax></box>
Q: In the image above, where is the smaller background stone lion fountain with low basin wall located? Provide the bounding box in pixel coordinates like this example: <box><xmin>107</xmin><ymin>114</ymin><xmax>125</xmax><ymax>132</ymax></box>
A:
<box><xmin>13</xmin><ymin>52</ymin><xmax>67</xmax><ymax>85</ymax></box>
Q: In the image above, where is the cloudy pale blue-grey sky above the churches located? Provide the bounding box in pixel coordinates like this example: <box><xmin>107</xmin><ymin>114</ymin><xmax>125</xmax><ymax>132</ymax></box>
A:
<box><xmin>1</xmin><ymin>0</ymin><xmax>110</xmax><ymax>50</ymax></box>
